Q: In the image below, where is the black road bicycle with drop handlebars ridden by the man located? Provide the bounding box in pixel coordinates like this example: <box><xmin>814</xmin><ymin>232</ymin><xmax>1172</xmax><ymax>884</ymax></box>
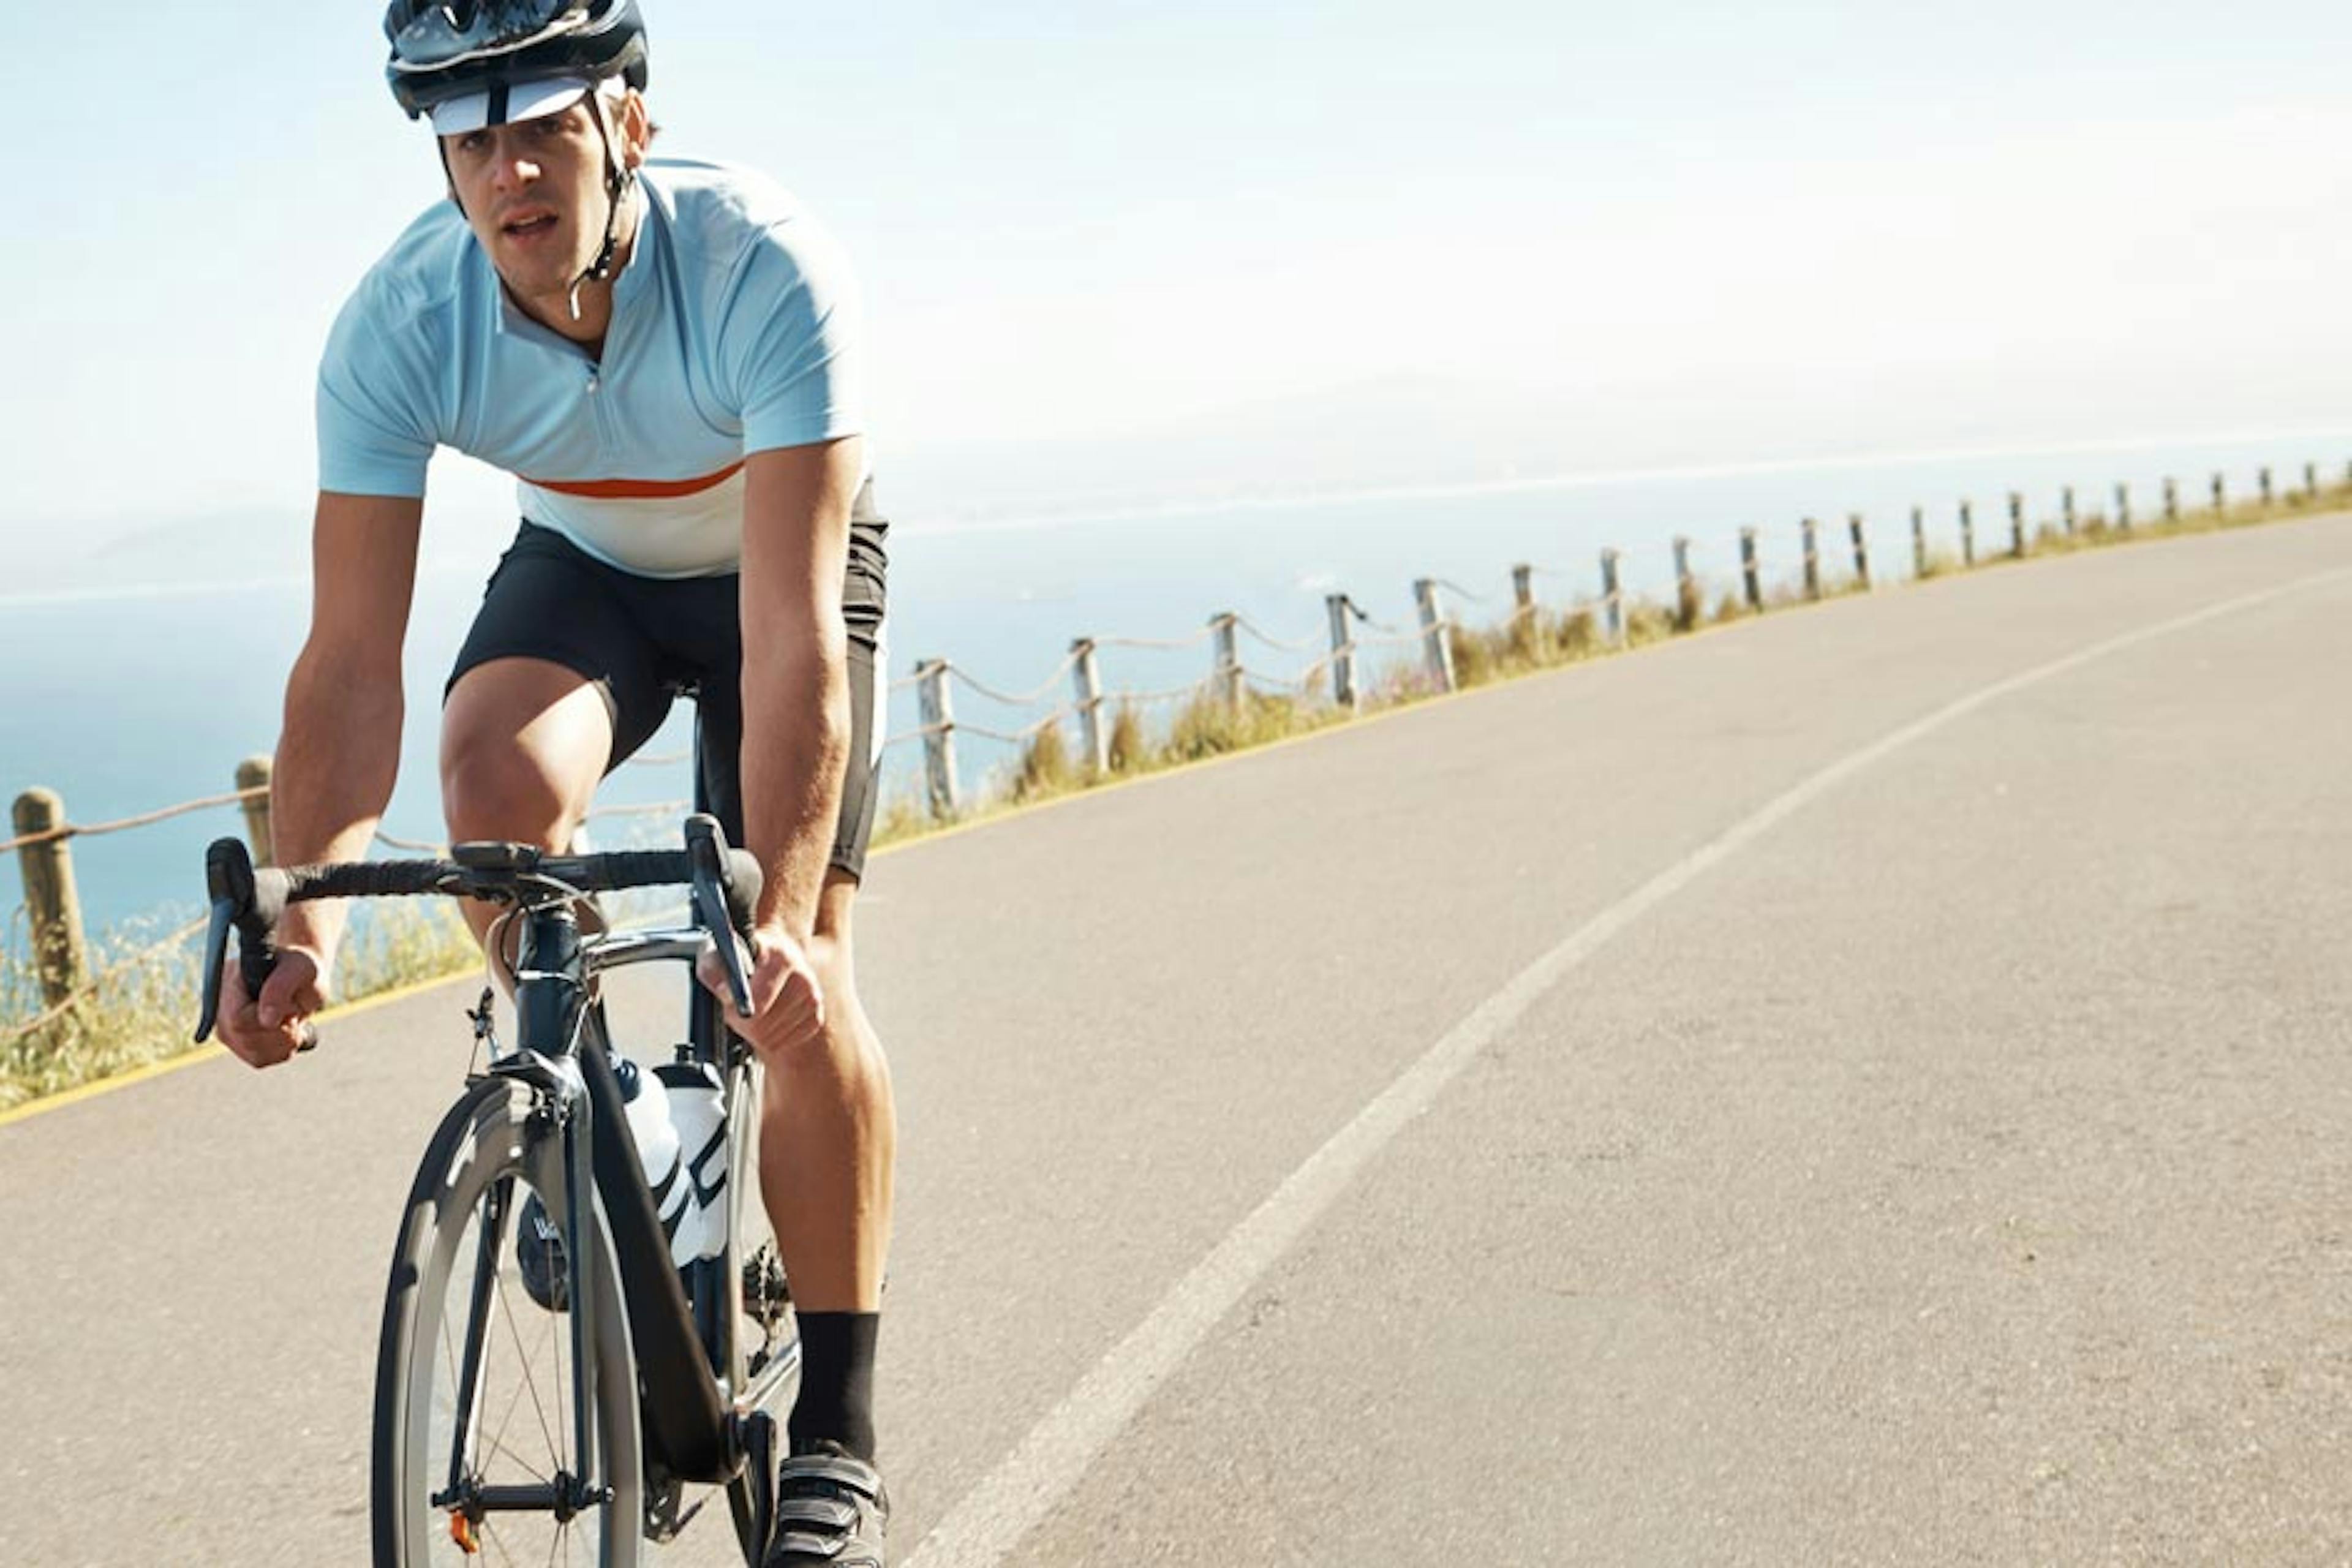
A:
<box><xmin>198</xmin><ymin>811</ymin><xmax>800</xmax><ymax>1568</ymax></box>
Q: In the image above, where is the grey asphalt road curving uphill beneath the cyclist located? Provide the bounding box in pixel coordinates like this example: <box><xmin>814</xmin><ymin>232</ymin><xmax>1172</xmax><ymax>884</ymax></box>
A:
<box><xmin>0</xmin><ymin>517</ymin><xmax>2352</xmax><ymax>1568</ymax></box>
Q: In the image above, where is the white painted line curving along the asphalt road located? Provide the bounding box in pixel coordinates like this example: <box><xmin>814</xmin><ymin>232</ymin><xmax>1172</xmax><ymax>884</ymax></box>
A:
<box><xmin>905</xmin><ymin>569</ymin><xmax>2352</xmax><ymax>1568</ymax></box>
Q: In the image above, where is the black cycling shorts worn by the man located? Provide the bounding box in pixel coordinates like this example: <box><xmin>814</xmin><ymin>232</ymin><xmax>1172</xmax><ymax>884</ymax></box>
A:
<box><xmin>442</xmin><ymin>482</ymin><xmax>889</xmax><ymax>877</ymax></box>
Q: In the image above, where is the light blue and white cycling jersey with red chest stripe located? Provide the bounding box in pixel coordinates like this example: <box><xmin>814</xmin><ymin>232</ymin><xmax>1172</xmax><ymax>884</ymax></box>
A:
<box><xmin>317</xmin><ymin>157</ymin><xmax>863</xmax><ymax>578</ymax></box>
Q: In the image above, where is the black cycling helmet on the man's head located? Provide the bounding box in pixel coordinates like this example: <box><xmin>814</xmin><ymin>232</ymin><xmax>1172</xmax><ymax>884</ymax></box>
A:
<box><xmin>383</xmin><ymin>0</ymin><xmax>644</xmax><ymax>120</ymax></box>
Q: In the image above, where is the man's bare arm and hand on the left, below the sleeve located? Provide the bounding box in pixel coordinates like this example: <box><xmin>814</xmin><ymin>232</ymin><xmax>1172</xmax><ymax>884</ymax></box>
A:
<box><xmin>221</xmin><ymin>491</ymin><xmax>423</xmax><ymax>1067</ymax></box>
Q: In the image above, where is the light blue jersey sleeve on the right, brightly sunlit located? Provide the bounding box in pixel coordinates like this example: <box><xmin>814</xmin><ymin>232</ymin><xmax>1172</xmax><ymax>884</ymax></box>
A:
<box><xmin>717</xmin><ymin>219</ymin><xmax>865</xmax><ymax>456</ymax></box>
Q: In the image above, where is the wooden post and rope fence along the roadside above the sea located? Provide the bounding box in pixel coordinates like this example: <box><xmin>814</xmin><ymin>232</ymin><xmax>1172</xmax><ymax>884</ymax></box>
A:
<box><xmin>18</xmin><ymin>463</ymin><xmax>2352</xmax><ymax>1044</ymax></box>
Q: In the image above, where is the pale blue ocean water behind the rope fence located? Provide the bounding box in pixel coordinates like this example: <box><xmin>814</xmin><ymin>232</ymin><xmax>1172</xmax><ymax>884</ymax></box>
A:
<box><xmin>0</xmin><ymin>430</ymin><xmax>2352</xmax><ymax>944</ymax></box>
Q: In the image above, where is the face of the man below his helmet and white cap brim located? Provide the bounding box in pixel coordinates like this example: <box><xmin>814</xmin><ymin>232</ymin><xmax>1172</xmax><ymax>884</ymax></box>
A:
<box><xmin>442</xmin><ymin>101</ymin><xmax>635</xmax><ymax>301</ymax></box>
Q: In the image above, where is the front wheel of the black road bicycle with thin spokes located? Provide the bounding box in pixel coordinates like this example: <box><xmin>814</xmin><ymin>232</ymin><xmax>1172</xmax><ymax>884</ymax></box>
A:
<box><xmin>369</xmin><ymin>1079</ymin><xmax>649</xmax><ymax>1568</ymax></box>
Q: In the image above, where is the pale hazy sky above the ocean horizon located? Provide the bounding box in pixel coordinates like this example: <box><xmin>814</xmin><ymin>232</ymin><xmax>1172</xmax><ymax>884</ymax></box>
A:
<box><xmin>0</xmin><ymin>0</ymin><xmax>2352</xmax><ymax>531</ymax></box>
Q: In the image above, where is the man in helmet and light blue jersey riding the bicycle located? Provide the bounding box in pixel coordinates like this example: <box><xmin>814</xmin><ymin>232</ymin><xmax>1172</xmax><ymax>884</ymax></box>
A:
<box><xmin>221</xmin><ymin>0</ymin><xmax>896</xmax><ymax>1568</ymax></box>
